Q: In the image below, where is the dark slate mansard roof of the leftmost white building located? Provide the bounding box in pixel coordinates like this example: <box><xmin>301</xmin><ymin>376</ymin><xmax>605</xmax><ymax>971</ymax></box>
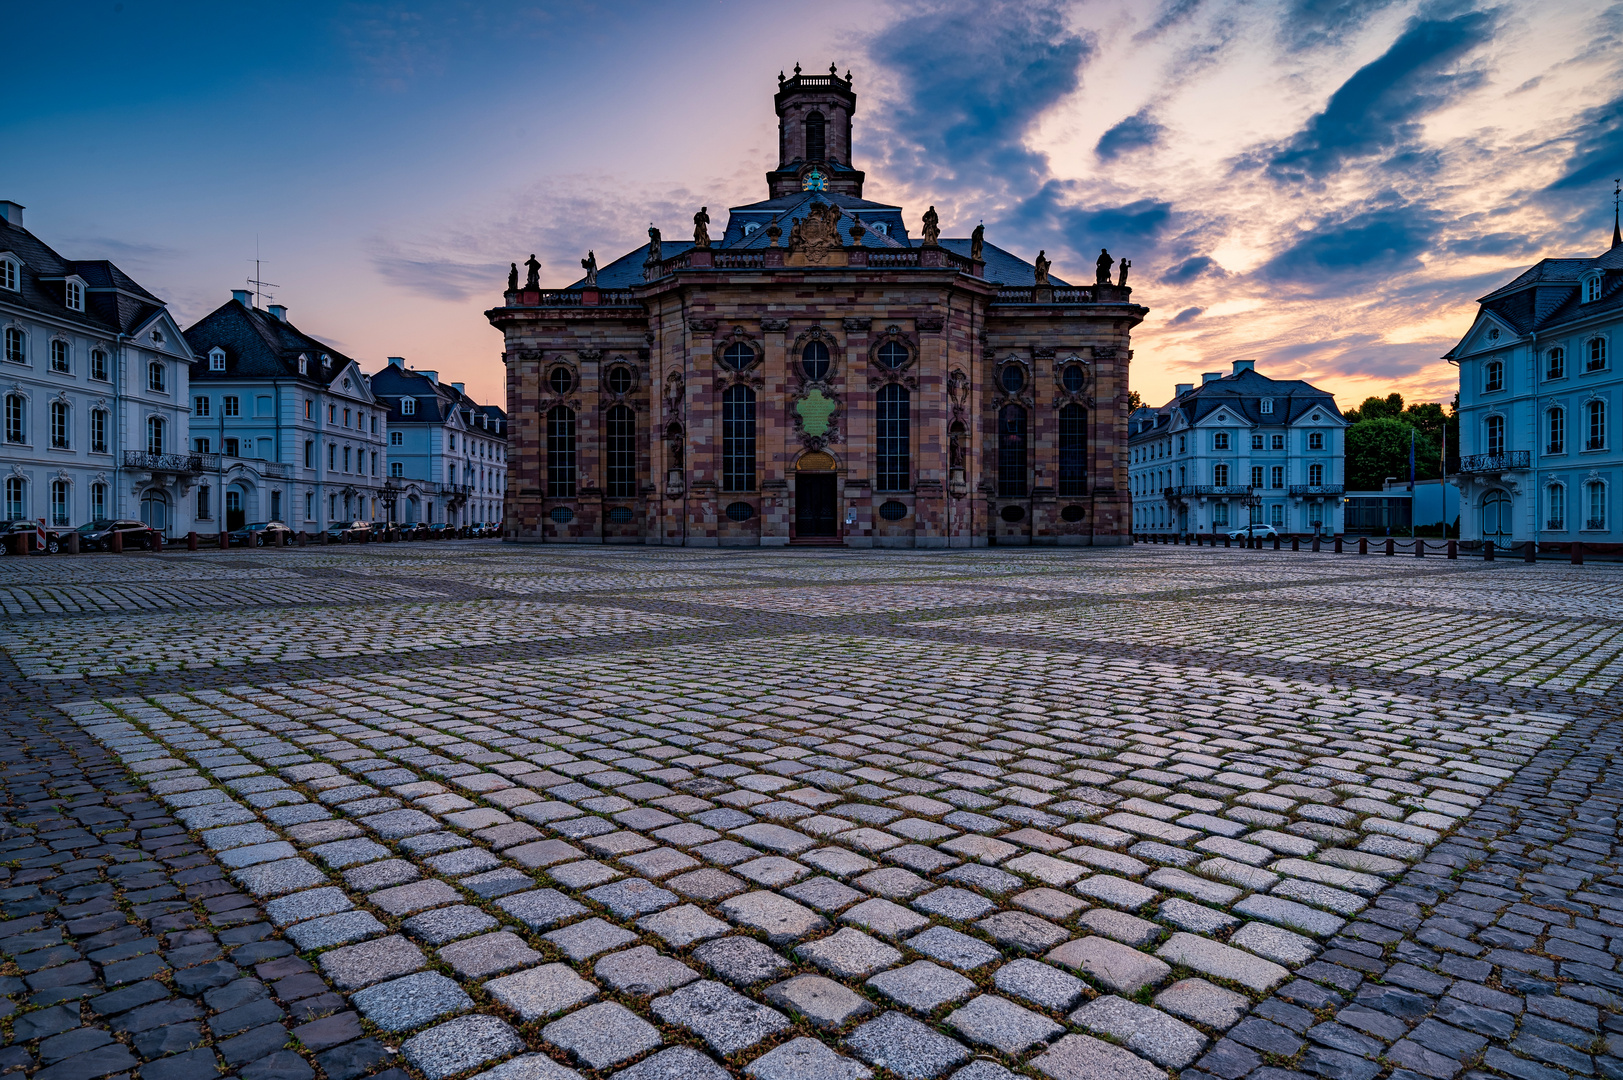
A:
<box><xmin>0</xmin><ymin>219</ymin><xmax>164</xmax><ymax>335</ymax></box>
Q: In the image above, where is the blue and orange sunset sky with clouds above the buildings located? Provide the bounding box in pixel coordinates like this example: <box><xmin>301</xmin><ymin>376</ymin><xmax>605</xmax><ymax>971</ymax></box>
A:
<box><xmin>12</xmin><ymin>0</ymin><xmax>1623</xmax><ymax>408</ymax></box>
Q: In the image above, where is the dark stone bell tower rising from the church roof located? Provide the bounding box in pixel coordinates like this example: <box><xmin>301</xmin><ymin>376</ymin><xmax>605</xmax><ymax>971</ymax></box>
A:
<box><xmin>766</xmin><ymin>63</ymin><xmax>863</xmax><ymax>198</ymax></box>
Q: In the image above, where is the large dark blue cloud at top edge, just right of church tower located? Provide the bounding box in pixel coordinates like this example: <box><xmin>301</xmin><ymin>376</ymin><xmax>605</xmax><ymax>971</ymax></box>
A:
<box><xmin>860</xmin><ymin>0</ymin><xmax>1094</xmax><ymax>188</ymax></box>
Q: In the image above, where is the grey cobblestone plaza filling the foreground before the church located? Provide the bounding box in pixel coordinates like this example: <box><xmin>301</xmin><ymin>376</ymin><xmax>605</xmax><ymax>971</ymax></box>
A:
<box><xmin>0</xmin><ymin>542</ymin><xmax>1623</xmax><ymax>1080</ymax></box>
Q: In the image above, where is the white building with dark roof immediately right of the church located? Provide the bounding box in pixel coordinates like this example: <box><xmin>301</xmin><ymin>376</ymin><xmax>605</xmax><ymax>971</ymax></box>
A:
<box><xmin>1128</xmin><ymin>361</ymin><xmax>1347</xmax><ymax>536</ymax></box>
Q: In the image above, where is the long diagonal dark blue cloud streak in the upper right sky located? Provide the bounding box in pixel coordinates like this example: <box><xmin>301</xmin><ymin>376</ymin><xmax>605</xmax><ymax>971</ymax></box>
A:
<box><xmin>1268</xmin><ymin>11</ymin><xmax>1495</xmax><ymax>184</ymax></box>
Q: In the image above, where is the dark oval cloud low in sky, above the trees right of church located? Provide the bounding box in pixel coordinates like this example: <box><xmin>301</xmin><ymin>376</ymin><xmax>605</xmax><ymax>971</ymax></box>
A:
<box><xmin>1258</xmin><ymin>206</ymin><xmax>1438</xmax><ymax>296</ymax></box>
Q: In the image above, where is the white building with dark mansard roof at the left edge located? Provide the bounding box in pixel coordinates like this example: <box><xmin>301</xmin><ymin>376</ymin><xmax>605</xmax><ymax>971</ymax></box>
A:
<box><xmin>0</xmin><ymin>201</ymin><xmax>201</xmax><ymax>536</ymax></box>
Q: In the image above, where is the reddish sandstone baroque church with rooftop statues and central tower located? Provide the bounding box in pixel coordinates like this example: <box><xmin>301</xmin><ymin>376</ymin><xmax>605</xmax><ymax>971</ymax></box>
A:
<box><xmin>487</xmin><ymin>65</ymin><xmax>1147</xmax><ymax>547</ymax></box>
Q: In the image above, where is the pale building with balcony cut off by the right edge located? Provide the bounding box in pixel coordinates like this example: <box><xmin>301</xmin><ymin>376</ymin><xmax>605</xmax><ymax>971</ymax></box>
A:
<box><xmin>1444</xmin><ymin>224</ymin><xmax>1623</xmax><ymax>546</ymax></box>
